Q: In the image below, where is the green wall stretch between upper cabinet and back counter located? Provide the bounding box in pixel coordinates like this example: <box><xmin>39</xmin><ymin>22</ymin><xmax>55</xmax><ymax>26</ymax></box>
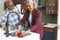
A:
<box><xmin>42</xmin><ymin>9</ymin><xmax>57</xmax><ymax>23</ymax></box>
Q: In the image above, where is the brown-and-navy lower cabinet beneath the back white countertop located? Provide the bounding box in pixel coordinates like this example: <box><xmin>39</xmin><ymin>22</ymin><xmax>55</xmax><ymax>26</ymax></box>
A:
<box><xmin>42</xmin><ymin>27</ymin><xmax>57</xmax><ymax>40</ymax></box>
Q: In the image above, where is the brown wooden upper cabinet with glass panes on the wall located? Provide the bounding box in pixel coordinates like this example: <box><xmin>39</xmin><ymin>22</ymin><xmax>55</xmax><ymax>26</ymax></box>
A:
<box><xmin>46</xmin><ymin>0</ymin><xmax>58</xmax><ymax>14</ymax></box>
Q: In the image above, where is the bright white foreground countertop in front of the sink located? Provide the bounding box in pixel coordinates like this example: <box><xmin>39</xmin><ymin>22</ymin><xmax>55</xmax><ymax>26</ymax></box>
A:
<box><xmin>0</xmin><ymin>28</ymin><xmax>40</xmax><ymax>40</ymax></box>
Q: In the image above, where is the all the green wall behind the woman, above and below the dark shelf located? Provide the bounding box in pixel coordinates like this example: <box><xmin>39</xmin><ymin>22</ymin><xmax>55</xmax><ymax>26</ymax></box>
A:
<box><xmin>40</xmin><ymin>0</ymin><xmax>57</xmax><ymax>23</ymax></box>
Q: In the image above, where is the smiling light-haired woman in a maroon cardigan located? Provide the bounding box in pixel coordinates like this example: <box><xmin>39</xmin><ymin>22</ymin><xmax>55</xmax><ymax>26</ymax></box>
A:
<box><xmin>16</xmin><ymin>0</ymin><xmax>43</xmax><ymax>39</ymax></box>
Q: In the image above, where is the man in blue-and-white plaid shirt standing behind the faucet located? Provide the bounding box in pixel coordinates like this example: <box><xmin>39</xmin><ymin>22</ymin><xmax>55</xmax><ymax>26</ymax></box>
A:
<box><xmin>2</xmin><ymin>0</ymin><xmax>20</xmax><ymax>30</ymax></box>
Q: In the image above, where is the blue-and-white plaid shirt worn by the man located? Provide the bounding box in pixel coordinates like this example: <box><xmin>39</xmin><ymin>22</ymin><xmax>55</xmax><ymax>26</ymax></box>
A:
<box><xmin>2</xmin><ymin>6</ymin><xmax>20</xmax><ymax>26</ymax></box>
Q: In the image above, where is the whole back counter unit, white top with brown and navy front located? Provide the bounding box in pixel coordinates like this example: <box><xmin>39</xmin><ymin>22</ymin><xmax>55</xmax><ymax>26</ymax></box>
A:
<box><xmin>43</xmin><ymin>23</ymin><xmax>57</xmax><ymax>40</ymax></box>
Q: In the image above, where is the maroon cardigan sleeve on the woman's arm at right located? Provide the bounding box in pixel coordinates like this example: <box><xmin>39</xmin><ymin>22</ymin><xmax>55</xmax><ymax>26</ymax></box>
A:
<box><xmin>30</xmin><ymin>11</ymin><xmax>42</xmax><ymax>32</ymax></box>
